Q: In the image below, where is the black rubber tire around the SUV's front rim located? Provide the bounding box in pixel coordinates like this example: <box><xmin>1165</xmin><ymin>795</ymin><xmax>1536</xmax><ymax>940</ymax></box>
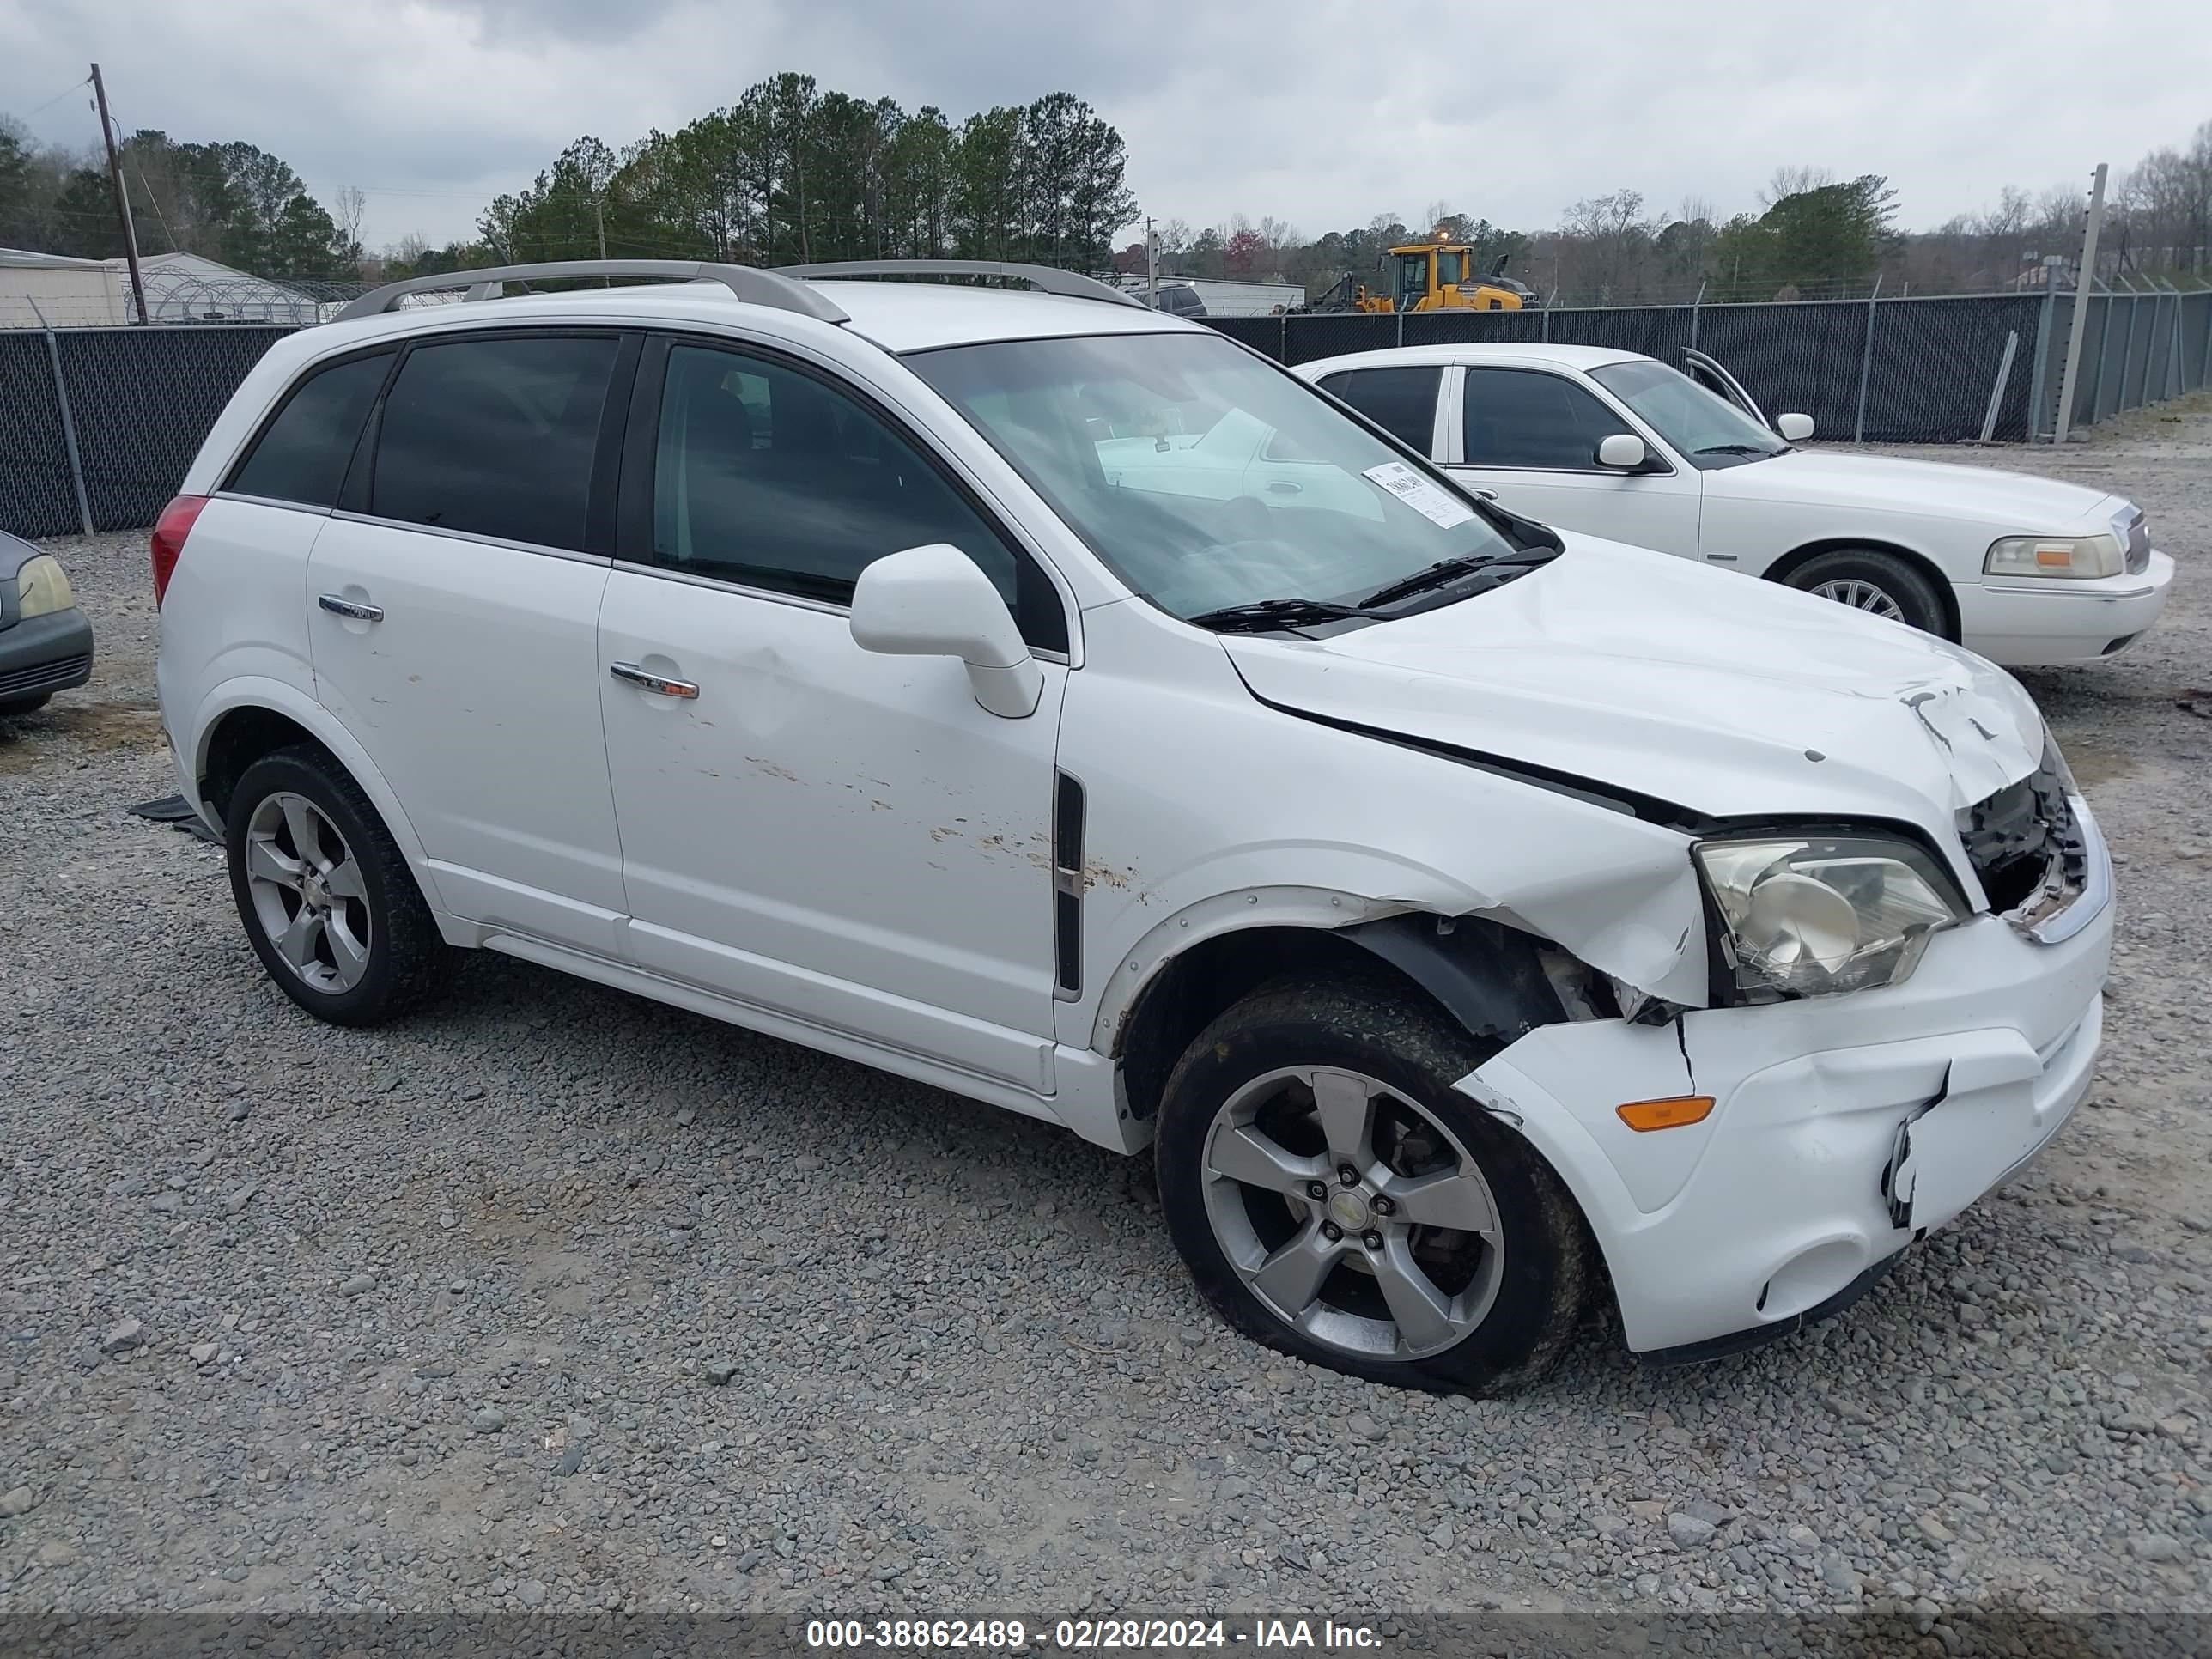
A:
<box><xmin>1152</xmin><ymin>980</ymin><xmax>1597</xmax><ymax>1394</ymax></box>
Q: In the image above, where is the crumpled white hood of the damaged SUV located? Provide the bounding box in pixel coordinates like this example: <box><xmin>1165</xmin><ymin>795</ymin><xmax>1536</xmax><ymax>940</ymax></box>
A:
<box><xmin>1221</xmin><ymin>535</ymin><xmax>2044</xmax><ymax>848</ymax></box>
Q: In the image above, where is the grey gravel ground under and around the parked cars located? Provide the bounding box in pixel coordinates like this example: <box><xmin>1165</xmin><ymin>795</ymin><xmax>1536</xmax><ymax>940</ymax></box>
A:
<box><xmin>0</xmin><ymin>410</ymin><xmax>2212</xmax><ymax>1620</ymax></box>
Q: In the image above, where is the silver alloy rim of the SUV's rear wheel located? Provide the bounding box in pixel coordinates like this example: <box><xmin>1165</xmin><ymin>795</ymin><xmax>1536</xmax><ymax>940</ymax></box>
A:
<box><xmin>246</xmin><ymin>792</ymin><xmax>374</xmax><ymax>995</ymax></box>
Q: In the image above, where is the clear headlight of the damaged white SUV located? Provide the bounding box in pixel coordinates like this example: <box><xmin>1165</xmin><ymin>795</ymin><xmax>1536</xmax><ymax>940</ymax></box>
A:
<box><xmin>1694</xmin><ymin>834</ymin><xmax>1969</xmax><ymax>998</ymax></box>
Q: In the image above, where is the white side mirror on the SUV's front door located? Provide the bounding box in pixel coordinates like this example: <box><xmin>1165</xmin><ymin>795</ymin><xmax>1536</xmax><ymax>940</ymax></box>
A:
<box><xmin>852</xmin><ymin>542</ymin><xmax>1044</xmax><ymax>721</ymax></box>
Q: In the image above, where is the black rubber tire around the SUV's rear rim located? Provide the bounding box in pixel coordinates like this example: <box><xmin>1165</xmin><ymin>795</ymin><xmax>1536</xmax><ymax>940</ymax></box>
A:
<box><xmin>223</xmin><ymin>744</ymin><xmax>465</xmax><ymax>1026</ymax></box>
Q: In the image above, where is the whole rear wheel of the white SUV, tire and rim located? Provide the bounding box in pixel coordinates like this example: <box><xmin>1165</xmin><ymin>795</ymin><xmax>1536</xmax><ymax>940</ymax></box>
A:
<box><xmin>223</xmin><ymin>745</ymin><xmax>460</xmax><ymax>1026</ymax></box>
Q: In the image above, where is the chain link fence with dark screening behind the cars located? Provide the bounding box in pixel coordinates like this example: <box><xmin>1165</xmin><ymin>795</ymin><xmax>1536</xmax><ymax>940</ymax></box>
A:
<box><xmin>0</xmin><ymin>289</ymin><xmax>2212</xmax><ymax>535</ymax></box>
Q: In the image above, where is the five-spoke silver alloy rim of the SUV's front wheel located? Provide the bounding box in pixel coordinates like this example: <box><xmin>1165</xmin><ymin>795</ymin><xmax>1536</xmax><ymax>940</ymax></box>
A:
<box><xmin>1203</xmin><ymin>1066</ymin><xmax>1504</xmax><ymax>1360</ymax></box>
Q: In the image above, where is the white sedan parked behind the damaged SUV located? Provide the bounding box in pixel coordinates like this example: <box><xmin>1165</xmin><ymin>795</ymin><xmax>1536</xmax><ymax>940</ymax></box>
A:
<box><xmin>1297</xmin><ymin>345</ymin><xmax>2174</xmax><ymax>668</ymax></box>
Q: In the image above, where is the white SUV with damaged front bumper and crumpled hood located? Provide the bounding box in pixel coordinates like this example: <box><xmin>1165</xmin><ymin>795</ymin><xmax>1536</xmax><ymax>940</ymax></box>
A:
<box><xmin>153</xmin><ymin>261</ymin><xmax>2112</xmax><ymax>1387</ymax></box>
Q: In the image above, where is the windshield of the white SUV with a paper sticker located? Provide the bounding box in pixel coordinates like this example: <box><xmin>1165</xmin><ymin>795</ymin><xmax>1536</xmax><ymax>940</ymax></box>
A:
<box><xmin>907</xmin><ymin>331</ymin><xmax>1524</xmax><ymax>622</ymax></box>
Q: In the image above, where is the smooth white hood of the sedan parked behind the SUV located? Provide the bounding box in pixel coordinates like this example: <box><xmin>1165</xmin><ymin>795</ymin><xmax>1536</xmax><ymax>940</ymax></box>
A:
<box><xmin>1705</xmin><ymin>449</ymin><xmax>2119</xmax><ymax>535</ymax></box>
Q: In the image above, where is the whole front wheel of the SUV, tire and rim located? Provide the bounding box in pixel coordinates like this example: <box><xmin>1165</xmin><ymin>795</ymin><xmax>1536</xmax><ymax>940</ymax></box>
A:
<box><xmin>1155</xmin><ymin>982</ymin><xmax>1593</xmax><ymax>1391</ymax></box>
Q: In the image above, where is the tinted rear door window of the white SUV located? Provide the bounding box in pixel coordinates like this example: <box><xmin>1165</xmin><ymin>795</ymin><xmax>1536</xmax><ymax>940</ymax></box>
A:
<box><xmin>369</xmin><ymin>337</ymin><xmax>619</xmax><ymax>550</ymax></box>
